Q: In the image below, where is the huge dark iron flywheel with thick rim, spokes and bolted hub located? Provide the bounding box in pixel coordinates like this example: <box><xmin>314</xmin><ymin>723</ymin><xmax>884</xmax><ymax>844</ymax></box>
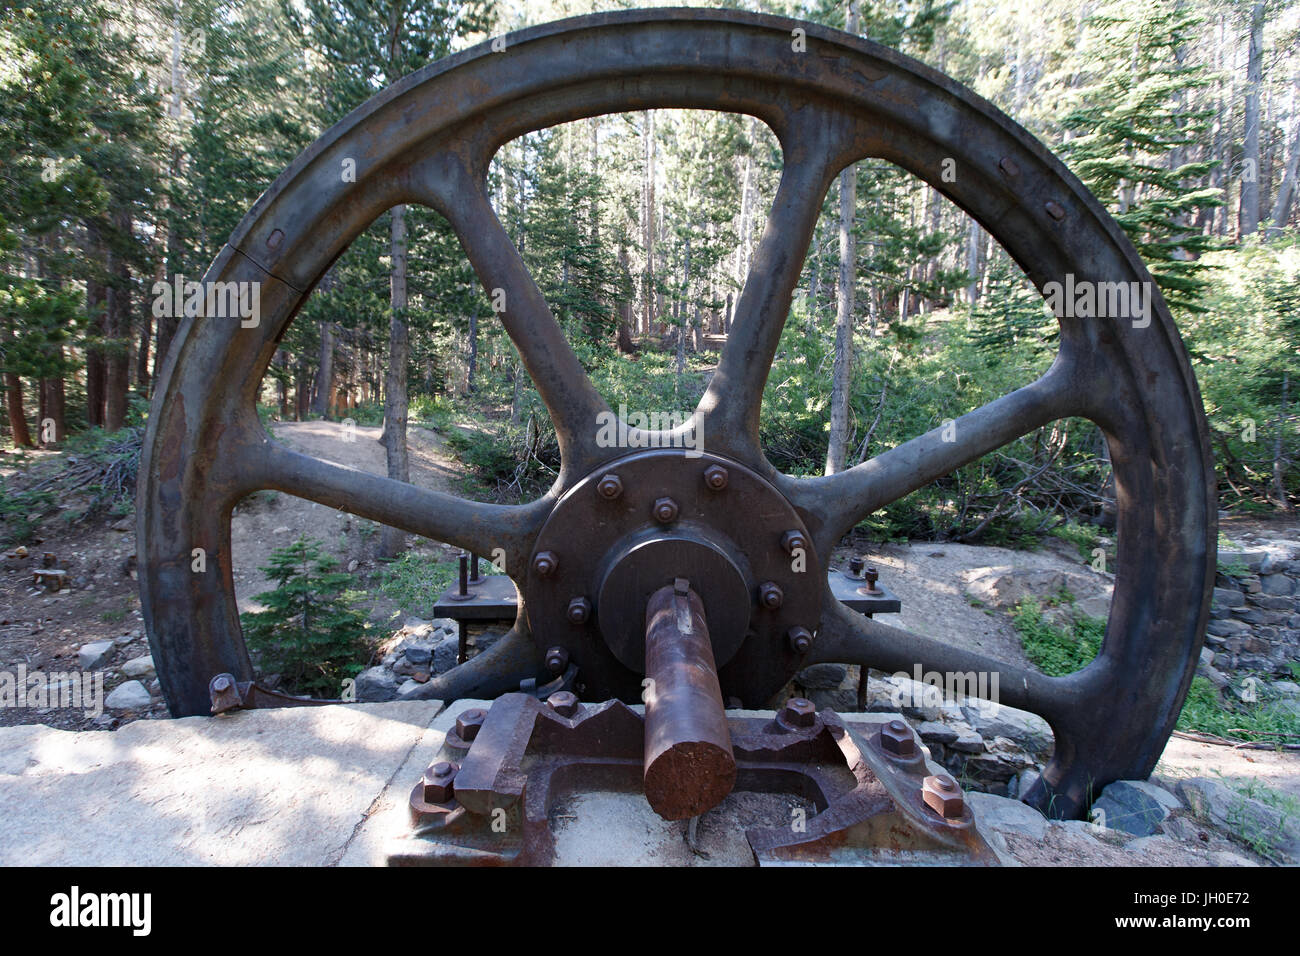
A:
<box><xmin>138</xmin><ymin>9</ymin><xmax>1217</xmax><ymax>816</ymax></box>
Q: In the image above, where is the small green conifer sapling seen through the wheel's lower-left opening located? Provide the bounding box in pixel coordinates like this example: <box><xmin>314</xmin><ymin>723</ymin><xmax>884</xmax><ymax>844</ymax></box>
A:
<box><xmin>239</xmin><ymin>536</ymin><xmax>371</xmax><ymax>696</ymax></box>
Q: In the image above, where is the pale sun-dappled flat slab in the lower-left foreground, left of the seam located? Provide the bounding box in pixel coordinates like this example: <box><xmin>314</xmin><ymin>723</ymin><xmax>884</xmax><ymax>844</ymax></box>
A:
<box><xmin>0</xmin><ymin>701</ymin><xmax>442</xmax><ymax>866</ymax></box>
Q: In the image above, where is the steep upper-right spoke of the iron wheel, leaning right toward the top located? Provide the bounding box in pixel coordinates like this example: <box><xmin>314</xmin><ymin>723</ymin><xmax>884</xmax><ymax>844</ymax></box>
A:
<box><xmin>698</xmin><ymin>109</ymin><xmax>852</xmax><ymax>463</ymax></box>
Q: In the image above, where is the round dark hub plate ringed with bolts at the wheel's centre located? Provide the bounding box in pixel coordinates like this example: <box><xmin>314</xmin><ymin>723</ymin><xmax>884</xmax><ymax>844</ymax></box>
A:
<box><xmin>524</xmin><ymin>449</ymin><xmax>824</xmax><ymax>708</ymax></box>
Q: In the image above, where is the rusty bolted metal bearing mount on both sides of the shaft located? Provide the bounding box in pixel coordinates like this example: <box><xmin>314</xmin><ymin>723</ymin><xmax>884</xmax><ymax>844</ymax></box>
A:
<box><xmin>389</xmin><ymin>693</ymin><xmax>996</xmax><ymax>866</ymax></box>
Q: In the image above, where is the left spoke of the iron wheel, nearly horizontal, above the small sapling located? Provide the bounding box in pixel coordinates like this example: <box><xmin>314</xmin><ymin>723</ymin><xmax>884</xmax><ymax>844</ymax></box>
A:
<box><xmin>250</xmin><ymin>441</ymin><xmax>550</xmax><ymax>574</ymax></box>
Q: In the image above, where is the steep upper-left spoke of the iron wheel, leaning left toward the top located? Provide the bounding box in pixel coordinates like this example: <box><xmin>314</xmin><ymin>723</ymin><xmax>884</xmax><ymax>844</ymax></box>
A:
<box><xmin>421</xmin><ymin>155</ymin><xmax>611</xmax><ymax>473</ymax></box>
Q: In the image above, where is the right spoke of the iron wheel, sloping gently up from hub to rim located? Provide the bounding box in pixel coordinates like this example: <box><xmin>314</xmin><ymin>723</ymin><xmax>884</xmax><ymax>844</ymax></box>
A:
<box><xmin>780</xmin><ymin>356</ymin><xmax>1083</xmax><ymax>549</ymax></box>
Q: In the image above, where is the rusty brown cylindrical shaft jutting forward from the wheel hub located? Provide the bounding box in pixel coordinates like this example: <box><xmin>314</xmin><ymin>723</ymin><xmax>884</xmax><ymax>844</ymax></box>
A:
<box><xmin>645</xmin><ymin>578</ymin><xmax>736</xmax><ymax>819</ymax></box>
